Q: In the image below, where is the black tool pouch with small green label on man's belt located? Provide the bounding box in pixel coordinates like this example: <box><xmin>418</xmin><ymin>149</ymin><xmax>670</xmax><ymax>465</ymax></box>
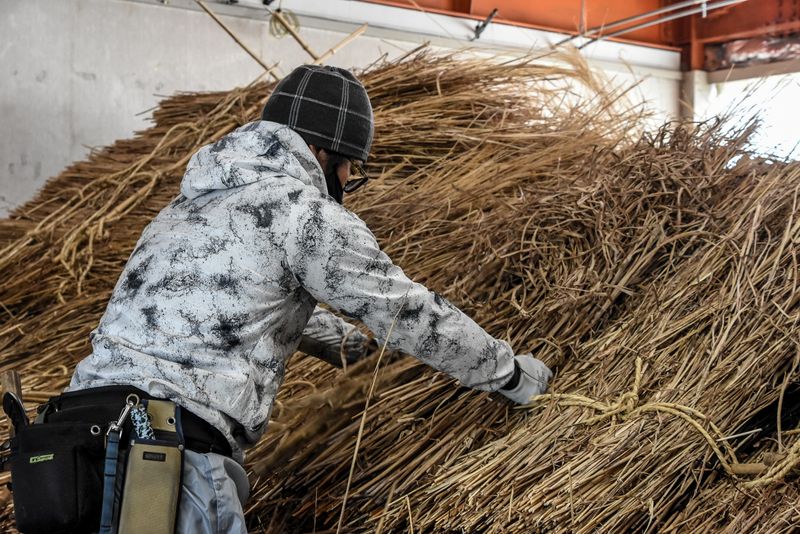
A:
<box><xmin>10</xmin><ymin>422</ymin><xmax>104</xmax><ymax>534</ymax></box>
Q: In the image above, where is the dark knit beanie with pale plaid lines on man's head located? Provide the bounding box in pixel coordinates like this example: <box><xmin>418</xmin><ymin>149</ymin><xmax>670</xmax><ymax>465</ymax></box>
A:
<box><xmin>261</xmin><ymin>65</ymin><xmax>374</xmax><ymax>161</ymax></box>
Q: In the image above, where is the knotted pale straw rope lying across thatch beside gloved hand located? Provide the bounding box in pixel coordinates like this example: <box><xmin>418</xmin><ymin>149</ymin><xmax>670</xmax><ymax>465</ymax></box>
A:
<box><xmin>524</xmin><ymin>358</ymin><xmax>800</xmax><ymax>488</ymax></box>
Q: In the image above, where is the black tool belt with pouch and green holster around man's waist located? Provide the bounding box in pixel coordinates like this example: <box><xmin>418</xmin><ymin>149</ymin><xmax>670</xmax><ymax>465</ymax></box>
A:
<box><xmin>4</xmin><ymin>386</ymin><xmax>231</xmax><ymax>534</ymax></box>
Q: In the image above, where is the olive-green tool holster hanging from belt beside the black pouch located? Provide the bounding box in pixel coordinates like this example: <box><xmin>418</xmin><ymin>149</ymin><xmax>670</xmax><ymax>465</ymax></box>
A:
<box><xmin>117</xmin><ymin>400</ymin><xmax>184</xmax><ymax>534</ymax></box>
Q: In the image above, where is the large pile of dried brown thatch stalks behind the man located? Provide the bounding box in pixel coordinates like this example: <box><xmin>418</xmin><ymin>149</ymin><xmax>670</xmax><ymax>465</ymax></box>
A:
<box><xmin>0</xmin><ymin>48</ymin><xmax>800</xmax><ymax>533</ymax></box>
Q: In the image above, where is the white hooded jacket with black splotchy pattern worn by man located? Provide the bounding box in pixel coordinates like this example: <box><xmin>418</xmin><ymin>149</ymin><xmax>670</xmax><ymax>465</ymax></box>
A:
<box><xmin>70</xmin><ymin>121</ymin><xmax>514</xmax><ymax>460</ymax></box>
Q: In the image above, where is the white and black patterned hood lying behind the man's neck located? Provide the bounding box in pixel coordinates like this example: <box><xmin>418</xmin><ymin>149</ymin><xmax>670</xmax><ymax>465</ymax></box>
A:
<box><xmin>181</xmin><ymin>121</ymin><xmax>328</xmax><ymax>199</ymax></box>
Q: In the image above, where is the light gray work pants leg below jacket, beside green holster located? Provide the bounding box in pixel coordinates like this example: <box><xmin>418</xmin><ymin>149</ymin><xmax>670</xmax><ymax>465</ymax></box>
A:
<box><xmin>175</xmin><ymin>450</ymin><xmax>250</xmax><ymax>534</ymax></box>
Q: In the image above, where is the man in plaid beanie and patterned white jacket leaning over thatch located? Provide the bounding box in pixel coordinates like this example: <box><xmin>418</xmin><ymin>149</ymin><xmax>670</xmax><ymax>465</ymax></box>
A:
<box><xmin>57</xmin><ymin>65</ymin><xmax>551</xmax><ymax>533</ymax></box>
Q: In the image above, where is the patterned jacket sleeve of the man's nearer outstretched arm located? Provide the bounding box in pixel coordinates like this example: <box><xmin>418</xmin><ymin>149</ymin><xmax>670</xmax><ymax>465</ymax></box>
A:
<box><xmin>286</xmin><ymin>198</ymin><xmax>514</xmax><ymax>391</ymax></box>
